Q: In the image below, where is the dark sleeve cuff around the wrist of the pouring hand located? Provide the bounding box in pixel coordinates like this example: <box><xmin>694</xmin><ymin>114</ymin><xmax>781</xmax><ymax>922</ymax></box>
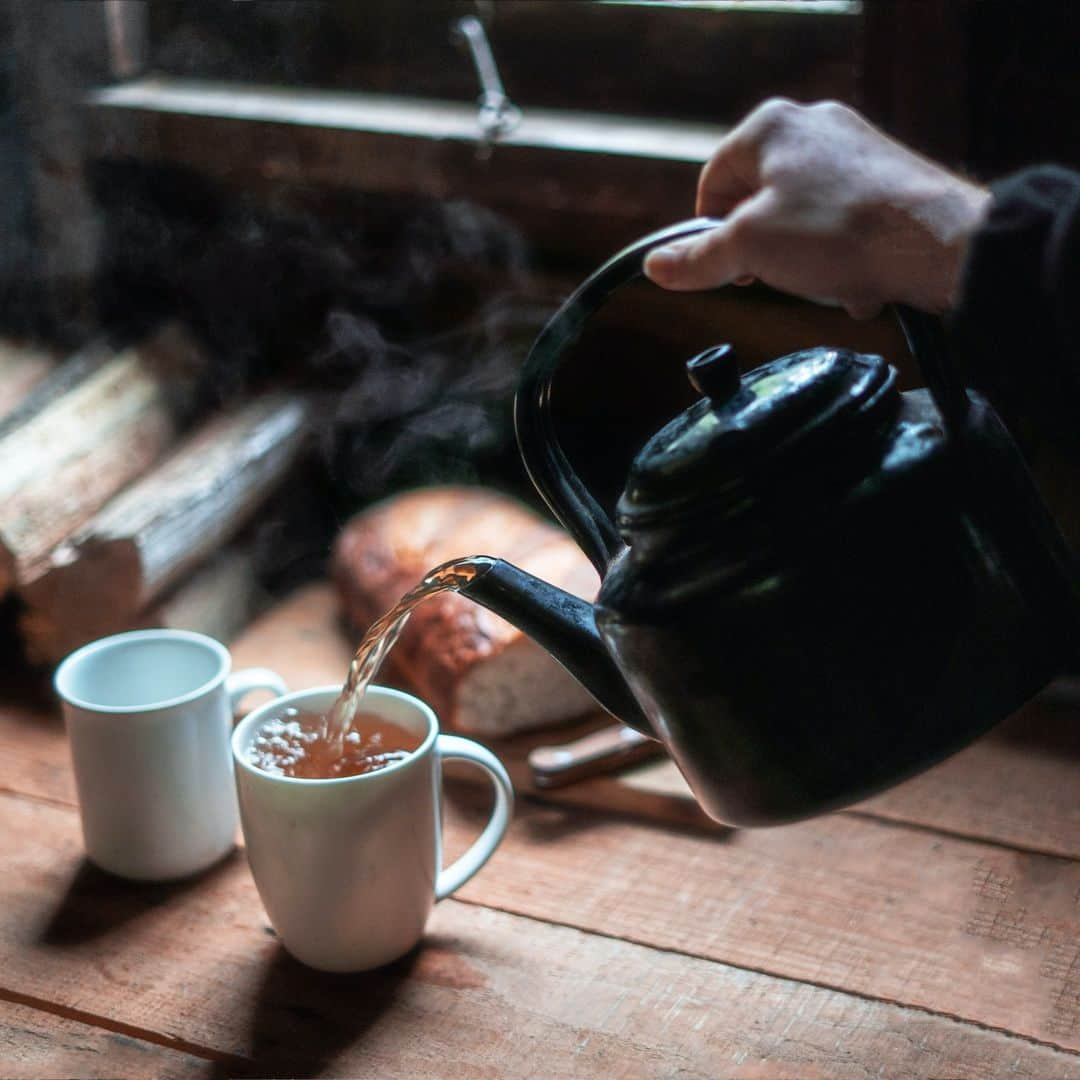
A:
<box><xmin>953</xmin><ymin>165</ymin><xmax>1080</xmax><ymax>442</ymax></box>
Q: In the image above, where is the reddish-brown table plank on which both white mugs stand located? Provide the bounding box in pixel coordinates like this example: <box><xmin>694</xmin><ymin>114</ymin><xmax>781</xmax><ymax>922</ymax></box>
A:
<box><xmin>0</xmin><ymin>797</ymin><xmax>1080</xmax><ymax>1078</ymax></box>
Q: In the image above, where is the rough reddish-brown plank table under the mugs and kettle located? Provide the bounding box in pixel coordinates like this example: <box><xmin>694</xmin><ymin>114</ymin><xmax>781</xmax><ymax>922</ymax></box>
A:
<box><xmin>0</xmin><ymin>591</ymin><xmax>1080</xmax><ymax>1080</ymax></box>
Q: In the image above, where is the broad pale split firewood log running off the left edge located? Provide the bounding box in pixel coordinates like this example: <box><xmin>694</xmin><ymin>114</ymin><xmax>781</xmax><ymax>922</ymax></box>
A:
<box><xmin>0</xmin><ymin>325</ymin><xmax>202</xmax><ymax>593</ymax></box>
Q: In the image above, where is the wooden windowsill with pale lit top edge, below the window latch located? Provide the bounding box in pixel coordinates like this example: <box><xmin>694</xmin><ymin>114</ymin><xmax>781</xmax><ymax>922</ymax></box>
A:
<box><xmin>85</xmin><ymin>77</ymin><xmax>726</xmax><ymax>262</ymax></box>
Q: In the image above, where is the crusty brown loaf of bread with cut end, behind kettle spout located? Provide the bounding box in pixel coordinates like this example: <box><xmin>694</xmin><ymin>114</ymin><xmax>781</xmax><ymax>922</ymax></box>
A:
<box><xmin>333</xmin><ymin>487</ymin><xmax>599</xmax><ymax>735</ymax></box>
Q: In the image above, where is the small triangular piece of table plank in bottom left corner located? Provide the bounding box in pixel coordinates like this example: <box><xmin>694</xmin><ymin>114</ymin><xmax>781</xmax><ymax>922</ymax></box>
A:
<box><xmin>0</xmin><ymin>991</ymin><xmax>206</xmax><ymax>1080</ymax></box>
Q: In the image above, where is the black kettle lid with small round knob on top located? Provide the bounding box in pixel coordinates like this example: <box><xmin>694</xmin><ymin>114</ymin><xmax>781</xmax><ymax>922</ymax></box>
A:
<box><xmin>618</xmin><ymin>345</ymin><xmax>900</xmax><ymax>531</ymax></box>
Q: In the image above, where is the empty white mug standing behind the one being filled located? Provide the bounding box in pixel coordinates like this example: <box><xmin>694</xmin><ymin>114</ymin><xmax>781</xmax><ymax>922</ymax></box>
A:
<box><xmin>54</xmin><ymin>630</ymin><xmax>286</xmax><ymax>881</ymax></box>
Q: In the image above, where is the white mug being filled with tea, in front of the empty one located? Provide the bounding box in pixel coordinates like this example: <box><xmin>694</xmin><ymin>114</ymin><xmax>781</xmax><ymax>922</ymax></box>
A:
<box><xmin>232</xmin><ymin>686</ymin><xmax>514</xmax><ymax>972</ymax></box>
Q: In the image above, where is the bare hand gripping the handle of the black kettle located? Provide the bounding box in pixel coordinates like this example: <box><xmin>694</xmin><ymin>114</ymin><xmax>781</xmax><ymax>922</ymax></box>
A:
<box><xmin>645</xmin><ymin>98</ymin><xmax>990</xmax><ymax>319</ymax></box>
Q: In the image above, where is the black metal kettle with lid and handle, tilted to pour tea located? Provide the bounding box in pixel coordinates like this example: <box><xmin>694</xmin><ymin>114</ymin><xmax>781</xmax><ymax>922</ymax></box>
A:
<box><xmin>462</xmin><ymin>218</ymin><xmax>1080</xmax><ymax>826</ymax></box>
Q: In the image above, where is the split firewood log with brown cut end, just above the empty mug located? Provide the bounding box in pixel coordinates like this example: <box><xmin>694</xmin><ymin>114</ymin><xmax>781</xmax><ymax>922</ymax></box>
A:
<box><xmin>18</xmin><ymin>392</ymin><xmax>308</xmax><ymax>636</ymax></box>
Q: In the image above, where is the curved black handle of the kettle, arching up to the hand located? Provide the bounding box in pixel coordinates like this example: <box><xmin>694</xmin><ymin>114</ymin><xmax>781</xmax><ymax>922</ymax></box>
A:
<box><xmin>514</xmin><ymin>217</ymin><xmax>970</xmax><ymax>577</ymax></box>
